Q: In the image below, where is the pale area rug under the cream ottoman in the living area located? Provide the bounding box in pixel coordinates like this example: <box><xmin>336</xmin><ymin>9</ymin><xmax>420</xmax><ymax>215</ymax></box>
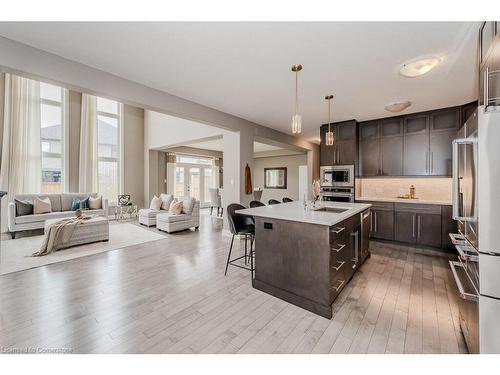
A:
<box><xmin>0</xmin><ymin>223</ymin><xmax>165</xmax><ymax>275</ymax></box>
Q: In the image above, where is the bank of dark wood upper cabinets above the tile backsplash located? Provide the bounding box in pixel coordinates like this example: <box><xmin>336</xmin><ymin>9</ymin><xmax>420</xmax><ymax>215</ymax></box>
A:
<box><xmin>328</xmin><ymin>102</ymin><xmax>468</xmax><ymax>177</ymax></box>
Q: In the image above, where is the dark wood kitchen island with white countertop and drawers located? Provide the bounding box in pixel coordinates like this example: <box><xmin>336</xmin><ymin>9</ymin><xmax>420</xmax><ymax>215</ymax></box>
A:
<box><xmin>237</xmin><ymin>202</ymin><xmax>371</xmax><ymax>319</ymax></box>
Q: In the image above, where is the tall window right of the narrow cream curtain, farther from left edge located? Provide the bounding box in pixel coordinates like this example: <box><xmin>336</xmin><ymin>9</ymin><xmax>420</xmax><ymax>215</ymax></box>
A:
<box><xmin>97</xmin><ymin>97</ymin><xmax>122</xmax><ymax>200</ymax></box>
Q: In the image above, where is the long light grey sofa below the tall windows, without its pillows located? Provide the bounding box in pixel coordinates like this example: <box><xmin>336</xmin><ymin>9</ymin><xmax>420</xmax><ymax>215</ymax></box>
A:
<box><xmin>8</xmin><ymin>193</ymin><xmax>108</xmax><ymax>238</ymax></box>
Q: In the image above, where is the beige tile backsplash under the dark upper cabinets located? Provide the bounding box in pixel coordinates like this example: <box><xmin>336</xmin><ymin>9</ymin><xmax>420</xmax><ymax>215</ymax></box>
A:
<box><xmin>356</xmin><ymin>177</ymin><xmax>452</xmax><ymax>201</ymax></box>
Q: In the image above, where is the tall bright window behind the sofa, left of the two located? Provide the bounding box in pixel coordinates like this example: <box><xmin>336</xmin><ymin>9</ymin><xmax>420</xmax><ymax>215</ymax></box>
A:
<box><xmin>40</xmin><ymin>82</ymin><xmax>67</xmax><ymax>193</ymax></box>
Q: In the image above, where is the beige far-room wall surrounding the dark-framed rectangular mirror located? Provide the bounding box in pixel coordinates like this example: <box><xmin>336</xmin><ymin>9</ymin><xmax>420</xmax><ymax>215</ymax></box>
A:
<box><xmin>253</xmin><ymin>154</ymin><xmax>307</xmax><ymax>203</ymax></box>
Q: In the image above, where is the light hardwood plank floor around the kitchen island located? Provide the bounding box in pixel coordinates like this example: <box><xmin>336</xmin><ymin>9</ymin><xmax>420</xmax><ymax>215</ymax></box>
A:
<box><xmin>0</xmin><ymin>216</ymin><xmax>467</xmax><ymax>353</ymax></box>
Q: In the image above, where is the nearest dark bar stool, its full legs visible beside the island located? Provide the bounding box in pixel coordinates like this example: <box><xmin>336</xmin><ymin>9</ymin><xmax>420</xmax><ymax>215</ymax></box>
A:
<box><xmin>224</xmin><ymin>203</ymin><xmax>255</xmax><ymax>280</ymax></box>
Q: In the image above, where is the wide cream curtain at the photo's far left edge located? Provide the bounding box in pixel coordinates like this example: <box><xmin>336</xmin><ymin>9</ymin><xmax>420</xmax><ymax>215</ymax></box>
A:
<box><xmin>0</xmin><ymin>73</ymin><xmax>42</xmax><ymax>200</ymax></box>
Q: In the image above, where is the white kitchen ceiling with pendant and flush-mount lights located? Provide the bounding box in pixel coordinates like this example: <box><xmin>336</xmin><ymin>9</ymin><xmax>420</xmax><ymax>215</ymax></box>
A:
<box><xmin>0</xmin><ymin>22</ymin><xmax>479</xmax><ymax>140</ymax></box>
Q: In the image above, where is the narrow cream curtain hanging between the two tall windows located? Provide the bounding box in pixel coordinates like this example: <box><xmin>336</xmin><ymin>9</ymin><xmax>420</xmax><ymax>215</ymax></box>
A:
<box><xmin>78</xmin><ymin>94</ymin><xmax>98</xmax><ymax>193</ymax></box>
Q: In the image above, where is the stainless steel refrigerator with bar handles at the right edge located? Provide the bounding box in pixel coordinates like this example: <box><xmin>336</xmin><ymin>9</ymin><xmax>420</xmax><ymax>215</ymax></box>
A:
<box><xmin>450</xmin><ymin>106</ymin><xmax>500</xmax><ymax>353</ymax></box>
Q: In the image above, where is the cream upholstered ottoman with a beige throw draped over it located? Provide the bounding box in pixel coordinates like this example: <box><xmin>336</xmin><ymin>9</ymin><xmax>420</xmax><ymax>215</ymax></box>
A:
<box><xmin>44</xmin><ymin>216</ymin><xmax>109</xmax><ymax>249</ymax></box>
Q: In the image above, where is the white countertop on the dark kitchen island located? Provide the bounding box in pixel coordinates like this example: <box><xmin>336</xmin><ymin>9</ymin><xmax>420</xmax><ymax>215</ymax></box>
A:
<box><xmin>236</xmin><ymin>201</ymin><xmax>371</xmax><ymax>226</ymax></box>
